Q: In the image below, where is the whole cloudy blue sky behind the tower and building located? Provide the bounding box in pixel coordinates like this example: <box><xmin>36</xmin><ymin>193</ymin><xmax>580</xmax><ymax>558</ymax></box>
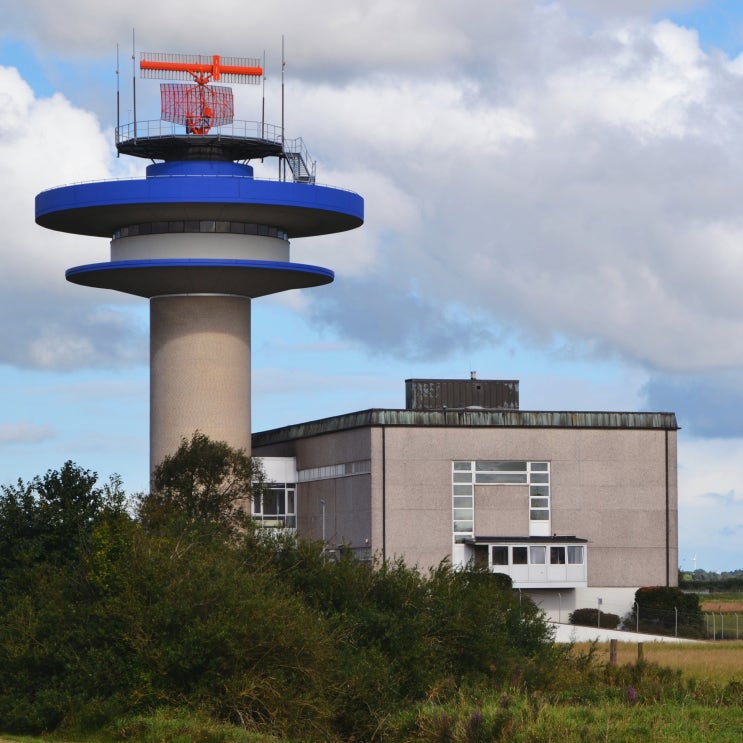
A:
<box><xmin>0</xmin><ymin>0</ymin><xmax>743</xmax><ymax>571</ymax></box>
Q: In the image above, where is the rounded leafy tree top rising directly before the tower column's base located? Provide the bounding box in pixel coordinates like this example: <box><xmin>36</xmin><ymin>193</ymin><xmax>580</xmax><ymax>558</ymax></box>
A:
<box><xmin>137</xmin><ymin>431</ymin><xmax>266</xmax><ymax>529</ymax></box>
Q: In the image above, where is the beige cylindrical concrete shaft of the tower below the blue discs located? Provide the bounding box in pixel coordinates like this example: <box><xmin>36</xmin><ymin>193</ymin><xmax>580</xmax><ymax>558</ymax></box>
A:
<box><xmin>150</xmin><ymin>294</ymin><xmax>250</xmax><ymax>471</ymax></box>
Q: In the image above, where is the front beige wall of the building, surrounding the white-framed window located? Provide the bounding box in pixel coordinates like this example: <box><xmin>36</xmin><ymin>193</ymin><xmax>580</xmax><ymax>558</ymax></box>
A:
<box><xmin>386</xmin><ymin>428</ymin><xmax>677</xmax><ymax>587</ymax></box>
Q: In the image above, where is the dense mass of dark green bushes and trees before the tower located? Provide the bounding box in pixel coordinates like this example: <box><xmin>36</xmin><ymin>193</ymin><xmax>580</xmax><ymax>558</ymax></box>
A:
<box><xmin>0</xmin><ymin>434</ymin><xmax>562</xmax><ymax>741</ymax></box>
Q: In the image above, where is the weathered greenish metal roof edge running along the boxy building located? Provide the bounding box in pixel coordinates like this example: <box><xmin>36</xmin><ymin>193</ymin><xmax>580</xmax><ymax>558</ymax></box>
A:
<box><xmin>252</xmin><ymin>408</ymin><xmax>679</xmax><ymax>448</ymax></box>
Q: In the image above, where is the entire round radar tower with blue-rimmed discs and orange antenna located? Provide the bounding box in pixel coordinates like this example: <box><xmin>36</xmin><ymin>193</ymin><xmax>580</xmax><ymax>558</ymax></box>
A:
<box><xmin>36</xmin><ymin>54</ymin><xmax>364</xmax><ymax>469</ymax></box>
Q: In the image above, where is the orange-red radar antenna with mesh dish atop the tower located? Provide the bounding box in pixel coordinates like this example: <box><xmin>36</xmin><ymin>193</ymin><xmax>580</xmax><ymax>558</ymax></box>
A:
<box><xmin>139</xmin><ymin>52</ymin><xmax>263</xmax><ymax>134</ymax></box>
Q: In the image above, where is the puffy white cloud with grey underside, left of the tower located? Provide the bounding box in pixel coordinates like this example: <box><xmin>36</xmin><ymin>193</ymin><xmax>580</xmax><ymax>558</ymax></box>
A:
<box><xmin>0</xmin><ymin>67</ymin><xmax>147</xmax><ymax>369</ymax></box>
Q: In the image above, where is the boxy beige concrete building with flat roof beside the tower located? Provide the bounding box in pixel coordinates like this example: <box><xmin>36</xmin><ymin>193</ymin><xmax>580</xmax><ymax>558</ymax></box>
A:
<box><xmin>253</xmin><ymin>378</ymin><xmax>678</xmax><ymax>621</ymax></box>
